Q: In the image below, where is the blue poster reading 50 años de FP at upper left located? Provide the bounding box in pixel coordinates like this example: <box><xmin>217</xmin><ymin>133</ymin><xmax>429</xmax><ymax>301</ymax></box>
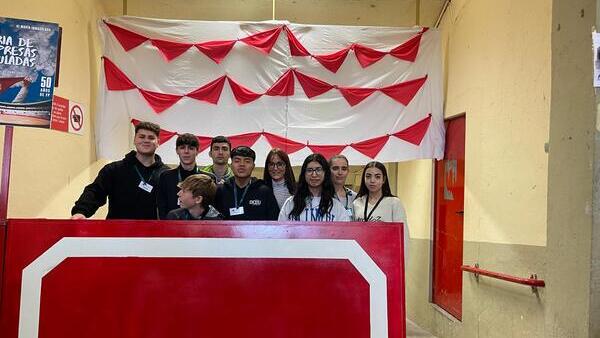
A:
<box><xmin>0</xmin><ymin>17</ymin><xmax>59</xmax><ymax>128</ymax></box>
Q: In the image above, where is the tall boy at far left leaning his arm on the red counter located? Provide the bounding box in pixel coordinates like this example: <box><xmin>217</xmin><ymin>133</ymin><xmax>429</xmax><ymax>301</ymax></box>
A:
<box><xmin>71</xmin><ymin>122</ymin><xmax>168</xmax><ymax>219</ymax></box>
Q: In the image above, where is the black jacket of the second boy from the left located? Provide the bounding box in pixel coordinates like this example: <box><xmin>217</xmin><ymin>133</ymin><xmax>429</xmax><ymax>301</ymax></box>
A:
<box><xmin>156</xmin><ymin>165</ymin><xmax>203</xmax><ymax>219</ymax></box>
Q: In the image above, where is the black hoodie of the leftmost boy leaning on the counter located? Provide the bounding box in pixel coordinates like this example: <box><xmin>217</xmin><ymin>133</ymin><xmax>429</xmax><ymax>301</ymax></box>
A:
<box><xmin>71</xmin><ymin>150</ymin><xmax>168</xmax><ymax>219</ymax></box>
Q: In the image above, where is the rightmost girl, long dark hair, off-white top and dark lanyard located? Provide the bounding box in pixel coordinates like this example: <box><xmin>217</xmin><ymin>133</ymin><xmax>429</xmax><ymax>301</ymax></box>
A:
<box><xmin>354</xmin><ymin>161</ymin><xmax>408</xmax><ymax>261</ymax></box>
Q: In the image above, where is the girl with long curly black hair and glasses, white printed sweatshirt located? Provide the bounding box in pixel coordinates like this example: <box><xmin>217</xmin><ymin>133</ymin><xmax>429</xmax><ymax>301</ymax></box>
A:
<box><xmin>278</xmin><ymin>154</ymin><xmax>350</xmax><ymax>222</ymax></box>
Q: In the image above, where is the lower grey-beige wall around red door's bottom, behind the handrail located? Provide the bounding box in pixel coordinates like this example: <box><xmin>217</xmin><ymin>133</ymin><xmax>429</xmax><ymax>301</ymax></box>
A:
<box><xmin>406</xmin><ymin>239</ymin><xmax>548</xmax><ymax>338</ymax></box>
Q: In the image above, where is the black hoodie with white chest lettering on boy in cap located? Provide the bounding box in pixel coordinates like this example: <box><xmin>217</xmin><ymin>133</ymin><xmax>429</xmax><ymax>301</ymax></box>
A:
<box><xmin>215</xmin><ymin>177</ymin><xmax>279</xmax><ymax>221</ymax></box>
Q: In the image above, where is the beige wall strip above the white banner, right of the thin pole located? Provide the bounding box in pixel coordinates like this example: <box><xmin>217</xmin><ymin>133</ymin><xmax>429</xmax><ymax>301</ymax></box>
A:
<box><xmin>275</xmin><ymin>0</ymin><xmax>416</xmax><ymax>27</ymax></box>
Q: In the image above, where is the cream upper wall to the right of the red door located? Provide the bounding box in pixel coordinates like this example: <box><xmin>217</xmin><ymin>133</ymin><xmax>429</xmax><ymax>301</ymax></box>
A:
<box><xmin>442</xmin><ymin>0</ymin><xmax>551</xmax><ymax>246</ymax></box>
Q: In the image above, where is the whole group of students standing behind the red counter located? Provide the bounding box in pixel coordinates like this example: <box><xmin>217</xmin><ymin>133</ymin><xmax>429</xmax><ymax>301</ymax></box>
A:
<box><xmin>71</xmin><ymin>122</ymin><xmax>407</xmax><ymax>238</ymax></box>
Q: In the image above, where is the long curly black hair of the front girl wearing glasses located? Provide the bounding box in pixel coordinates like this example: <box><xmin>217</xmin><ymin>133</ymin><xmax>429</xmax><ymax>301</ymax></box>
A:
<box><xmin>288</xmin><ymin>154</ymin><xmax>335</xmax><ymax>220</ymax></box>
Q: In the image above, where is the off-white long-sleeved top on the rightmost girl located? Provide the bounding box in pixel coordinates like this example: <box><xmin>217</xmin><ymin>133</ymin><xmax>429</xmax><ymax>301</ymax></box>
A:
<box><xmin>353</xmin><ymin>196</ymin><xmax>409</xmax><ymax>261</ymax></box>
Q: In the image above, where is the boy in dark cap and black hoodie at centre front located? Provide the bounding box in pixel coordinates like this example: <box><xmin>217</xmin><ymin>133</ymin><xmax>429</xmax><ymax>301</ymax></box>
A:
<box><xmin>215</xmin><ymin>146</ymin><xmax>279</xmax><ymax>221</ymax></box>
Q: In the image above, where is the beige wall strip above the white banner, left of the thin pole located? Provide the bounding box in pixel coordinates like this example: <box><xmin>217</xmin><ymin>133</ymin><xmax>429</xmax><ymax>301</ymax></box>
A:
<box><xmin>126</xmin><ymin>0</ymin><xmax>273</xmax><ymax>21</ymax></box>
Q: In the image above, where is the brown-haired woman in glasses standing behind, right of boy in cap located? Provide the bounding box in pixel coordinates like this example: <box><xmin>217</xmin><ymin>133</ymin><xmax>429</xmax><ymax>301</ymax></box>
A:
<box><xmin>263</xmin><ymin>148</ymin><xmax>296</xmax><ymax>209</ymax></box>
